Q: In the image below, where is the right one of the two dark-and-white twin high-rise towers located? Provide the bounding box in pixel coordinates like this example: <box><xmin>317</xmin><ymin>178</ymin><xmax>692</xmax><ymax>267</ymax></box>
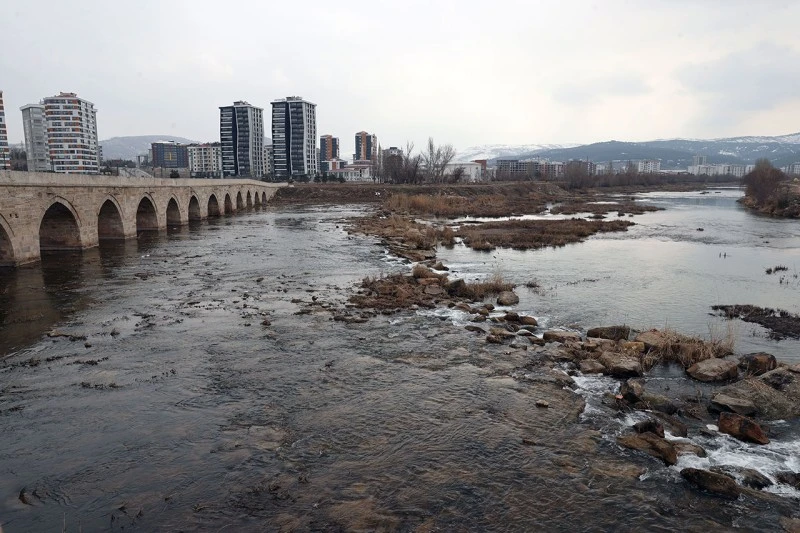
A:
<box><xmin>272</xmin><ymin>96</ymin><xmax>317</xmax><ymax>179</ymax></box>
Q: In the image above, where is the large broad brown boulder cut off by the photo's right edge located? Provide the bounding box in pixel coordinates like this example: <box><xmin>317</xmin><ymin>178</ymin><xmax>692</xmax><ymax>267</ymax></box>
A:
<box><xmin>717</xmin><ymin>367</ymin><xmax>800</xmax><ymax>420</ymax></box>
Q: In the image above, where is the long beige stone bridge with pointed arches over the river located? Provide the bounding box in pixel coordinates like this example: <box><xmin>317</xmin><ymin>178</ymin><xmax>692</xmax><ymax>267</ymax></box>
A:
<box><xmin>0</xmin><ymin>171</ymin><xmax>284</xmax><ymax>266</ymax></box>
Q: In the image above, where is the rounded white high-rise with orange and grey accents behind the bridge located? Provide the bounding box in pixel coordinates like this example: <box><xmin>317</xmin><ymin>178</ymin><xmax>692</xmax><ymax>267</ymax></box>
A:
<box><xmin>42</xmin><ymin>93</ymin><xmax>100</xmax><ymax>174</ymax></box>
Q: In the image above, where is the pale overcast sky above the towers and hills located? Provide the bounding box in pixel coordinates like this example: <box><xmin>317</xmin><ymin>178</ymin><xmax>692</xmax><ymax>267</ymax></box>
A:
<box><xmin>0</xmin><ymin>0</ymin><xmax>800</xmax><ymax>156</ymax></box>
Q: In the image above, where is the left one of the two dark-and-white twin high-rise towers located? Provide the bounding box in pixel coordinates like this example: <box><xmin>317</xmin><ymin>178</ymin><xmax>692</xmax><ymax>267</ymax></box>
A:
<box><xmin>219</xmin><ymin>101</ymin><xmax>264</xmax><ymax>178</ymax></box>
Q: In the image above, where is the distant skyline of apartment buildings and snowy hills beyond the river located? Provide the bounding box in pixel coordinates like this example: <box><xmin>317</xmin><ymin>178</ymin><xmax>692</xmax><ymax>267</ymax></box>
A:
<box><xmin>0</xmin><ymin>91</ymin><xmax>800</xmax><ymax>183</ymax></box>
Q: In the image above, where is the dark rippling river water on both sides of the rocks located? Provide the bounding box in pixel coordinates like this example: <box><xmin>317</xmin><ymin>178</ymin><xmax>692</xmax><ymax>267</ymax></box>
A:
<box><xmin>0</xmin><ymin>191</ymin><xmax>800</xmax><ymax>533</ymax></box>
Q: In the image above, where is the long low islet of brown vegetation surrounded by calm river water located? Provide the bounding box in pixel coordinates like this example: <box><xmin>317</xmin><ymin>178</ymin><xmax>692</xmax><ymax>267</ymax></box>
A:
<box><xmin>458</xmin><ymin>218</ymin><xmax>633</xmax><ymax>251</ymax></box>
